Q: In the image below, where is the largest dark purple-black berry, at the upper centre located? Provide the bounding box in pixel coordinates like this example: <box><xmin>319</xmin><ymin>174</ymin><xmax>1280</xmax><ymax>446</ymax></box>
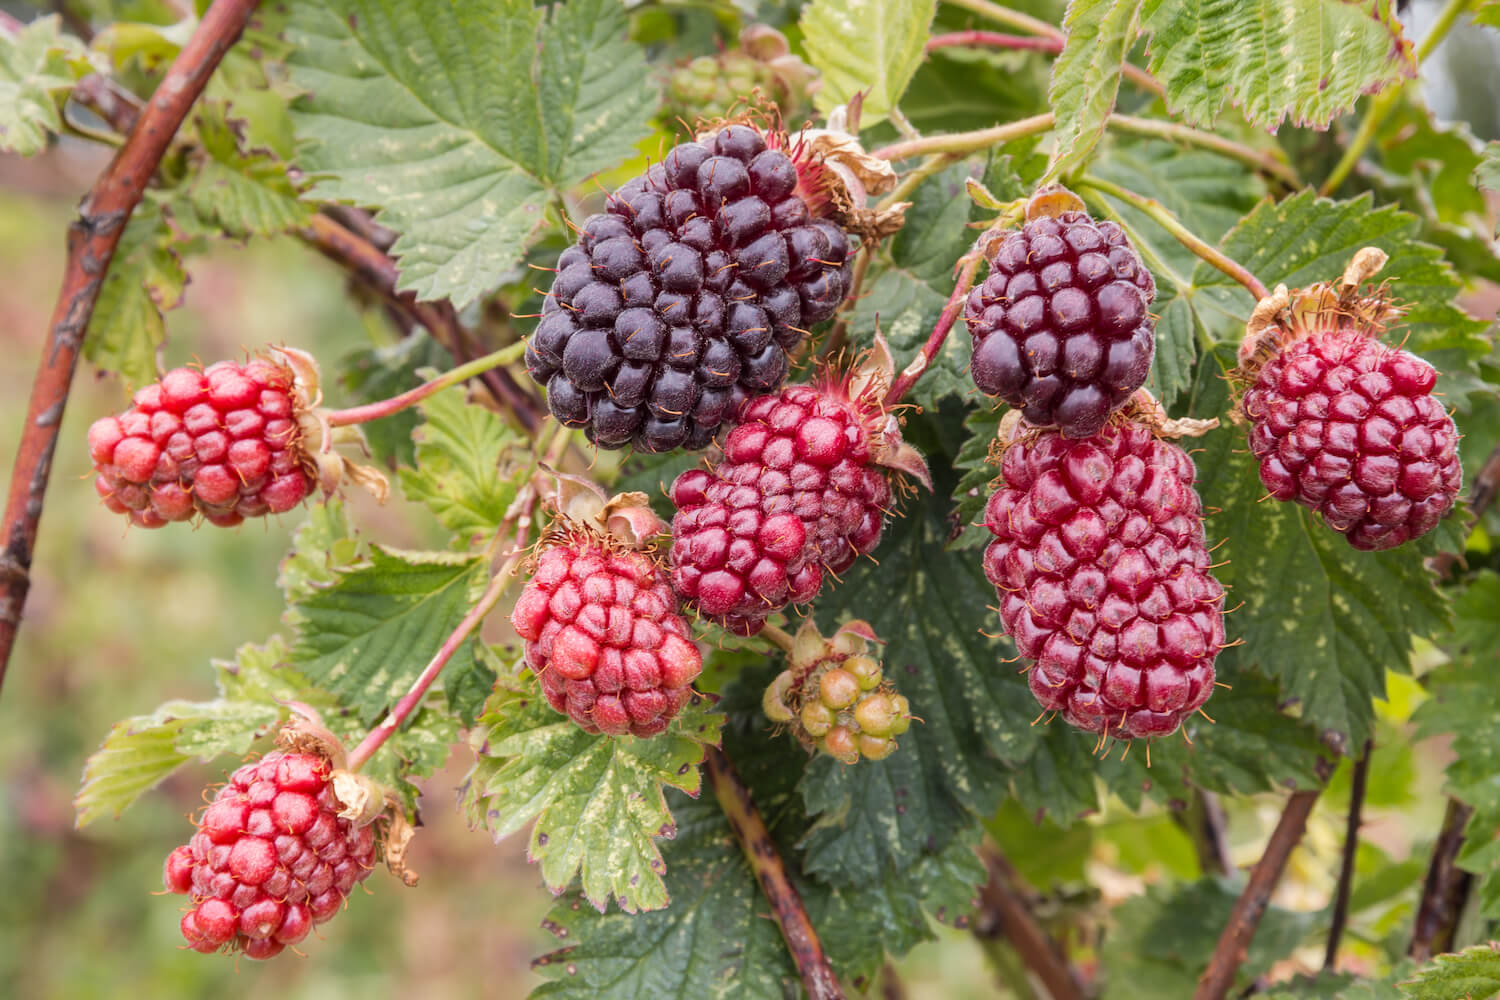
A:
<box><xmin>527</xmin><ymin>124</ymin><xmax>851</xmax><ymax>451</ymax></box>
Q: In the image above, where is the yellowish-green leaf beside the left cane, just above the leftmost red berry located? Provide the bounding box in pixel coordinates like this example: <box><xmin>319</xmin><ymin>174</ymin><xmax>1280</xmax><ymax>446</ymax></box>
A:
<box><xmin>84</xmin><ymin>201</ymin><xmax>188</xmax><ymax>385</ymax></box>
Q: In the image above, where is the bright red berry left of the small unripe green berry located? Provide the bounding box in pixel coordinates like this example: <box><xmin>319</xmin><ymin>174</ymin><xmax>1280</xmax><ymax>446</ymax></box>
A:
<box><xmin>510</xmin><ymin>528</ymin><xmax>704</xmax><ymax>736</ymax></box>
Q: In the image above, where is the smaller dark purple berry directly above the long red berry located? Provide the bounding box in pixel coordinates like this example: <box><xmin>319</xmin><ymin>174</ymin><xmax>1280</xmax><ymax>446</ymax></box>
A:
<box><xmin>965</xmin><ymin>211</ymin><xmax>1157</xmax><ymax>438</ymax></box>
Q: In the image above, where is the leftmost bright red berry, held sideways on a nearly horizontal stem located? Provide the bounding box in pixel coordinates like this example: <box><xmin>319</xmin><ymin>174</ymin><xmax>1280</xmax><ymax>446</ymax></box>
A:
<box><xmin>89</xmin><ymin>360</ymin><xmax>315</xmax><ymax>528</ymax></box>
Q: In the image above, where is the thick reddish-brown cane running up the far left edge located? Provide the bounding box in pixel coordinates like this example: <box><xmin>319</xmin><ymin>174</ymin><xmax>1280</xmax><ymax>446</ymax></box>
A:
<box><xmin>0</xmin><ymin>0</ymin><xmax>258</xmax><ymax>684</ymax></box>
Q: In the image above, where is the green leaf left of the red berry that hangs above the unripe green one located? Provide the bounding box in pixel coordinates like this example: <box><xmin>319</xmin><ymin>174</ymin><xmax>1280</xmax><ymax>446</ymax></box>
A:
<box><xmin>288</xmin><ymin>546</ymin><xmax>485</xmax><ymax>724</ymax></box>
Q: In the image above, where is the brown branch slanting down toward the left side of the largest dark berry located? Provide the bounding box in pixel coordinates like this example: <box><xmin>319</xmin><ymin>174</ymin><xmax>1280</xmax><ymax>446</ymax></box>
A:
<box><xmin>299</xmin><ymin>214</ymin><xmax>545</xmax><ymax>433</ymax></box>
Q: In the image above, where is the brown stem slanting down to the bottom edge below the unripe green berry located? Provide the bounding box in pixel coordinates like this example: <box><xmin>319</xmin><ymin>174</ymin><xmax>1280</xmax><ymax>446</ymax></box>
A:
<box><xmin>704</xmin><ymin>747</ymin><xmax>845</xmax><ymax>1000</ymax></box>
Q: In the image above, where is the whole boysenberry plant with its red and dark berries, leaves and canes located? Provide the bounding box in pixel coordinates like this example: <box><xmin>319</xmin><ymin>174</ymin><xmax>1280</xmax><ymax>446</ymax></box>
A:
<box><xmin>0</xmin><ymin>0</ymin><xmax>1500</xmax><ymax>1000</ymax></box>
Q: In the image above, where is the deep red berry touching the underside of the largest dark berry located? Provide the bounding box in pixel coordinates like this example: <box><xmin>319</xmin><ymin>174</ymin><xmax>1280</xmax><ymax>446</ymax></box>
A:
<box><xmin>672</xmin><ymin>379</ymin><xmax>920</xmax><ymax>636</ymax></box>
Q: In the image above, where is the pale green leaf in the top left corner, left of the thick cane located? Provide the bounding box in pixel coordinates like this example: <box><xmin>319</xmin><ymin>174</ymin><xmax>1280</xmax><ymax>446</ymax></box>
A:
<box><xmin>0</xmin><ymin>13</ymin><xmax>98</xmax><ymax>156</ymax></box>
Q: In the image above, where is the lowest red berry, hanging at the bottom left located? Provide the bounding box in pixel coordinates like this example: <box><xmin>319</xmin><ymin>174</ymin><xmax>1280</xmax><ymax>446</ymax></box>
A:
<box><xmin>162</xmin><ymin>750</ymin><xmax>375</xmax><ymax>958</ymax></box>
